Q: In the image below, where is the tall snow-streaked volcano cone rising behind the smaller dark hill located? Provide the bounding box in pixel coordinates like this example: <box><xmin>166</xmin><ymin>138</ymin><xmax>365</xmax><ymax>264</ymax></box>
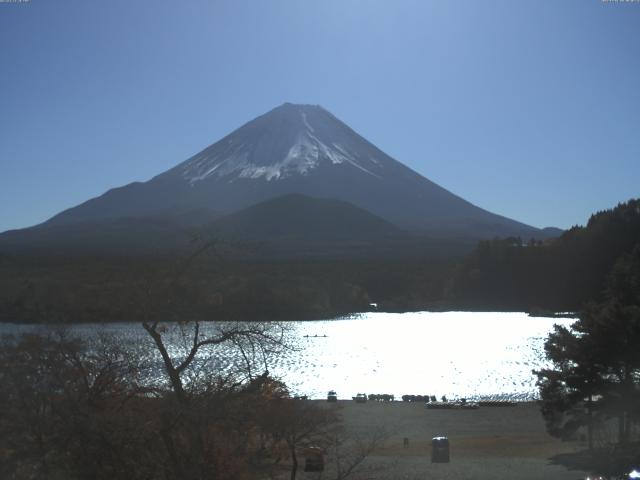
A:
<box><xmin>17</xmin><ymin>103</ymin><xmax>547</xmax><ymax>239</ymax></box>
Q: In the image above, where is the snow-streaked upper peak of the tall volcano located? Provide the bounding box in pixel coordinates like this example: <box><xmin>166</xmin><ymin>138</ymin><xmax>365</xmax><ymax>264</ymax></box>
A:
<box><xmin>179</xmin><ymin>103</ymin><xmax>381</xmax><ymax>185</ymax></box>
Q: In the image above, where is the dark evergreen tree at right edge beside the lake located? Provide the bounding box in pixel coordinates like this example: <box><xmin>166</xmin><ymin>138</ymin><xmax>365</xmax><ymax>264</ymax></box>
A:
<box><xmin>536</xmin><ymin>244</ymin><xmax>640</xmax><ymax>448</ymax></box>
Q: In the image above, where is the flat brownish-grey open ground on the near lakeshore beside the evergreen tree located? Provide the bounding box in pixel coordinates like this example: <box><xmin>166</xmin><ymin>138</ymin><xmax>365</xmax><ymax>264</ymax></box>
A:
<box><xmin>298</xmin><ymin>401</ymin><xmax>587</xmax><ymax>480</ymax></box>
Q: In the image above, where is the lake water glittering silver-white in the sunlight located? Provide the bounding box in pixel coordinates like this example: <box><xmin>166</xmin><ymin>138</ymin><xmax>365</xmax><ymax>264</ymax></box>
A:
<box><xmin>0</xmin><ymin>312</ymin><xmax>574</xmax><ymax>400</ymax></box>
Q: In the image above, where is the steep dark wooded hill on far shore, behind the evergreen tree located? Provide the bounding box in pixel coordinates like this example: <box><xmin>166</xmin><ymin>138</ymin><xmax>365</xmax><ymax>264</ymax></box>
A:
<box><xmin>448</xmin><ymin>199</ymin><xmax>640</xmax><ymax>311</ymax></box>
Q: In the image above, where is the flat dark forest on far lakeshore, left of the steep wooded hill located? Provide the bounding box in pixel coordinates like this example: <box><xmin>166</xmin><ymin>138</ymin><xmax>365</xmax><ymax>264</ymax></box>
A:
<box><xmin>0</xmin><ymin>252</ymin><xmax>454</xmax><ymax>323</ymax></box>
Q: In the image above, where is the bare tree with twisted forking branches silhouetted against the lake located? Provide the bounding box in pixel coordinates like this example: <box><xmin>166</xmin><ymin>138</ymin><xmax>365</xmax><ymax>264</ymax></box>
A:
<box><xmin>129</xmin><ymin>240</ymin><xmax>300</xmax><ymax>480</ymax></box>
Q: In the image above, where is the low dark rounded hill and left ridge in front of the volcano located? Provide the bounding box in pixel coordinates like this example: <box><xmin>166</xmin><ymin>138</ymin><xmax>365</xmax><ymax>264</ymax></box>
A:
<box><xmin>0</xmin><ymin>194</ymin><xmax>402</xmax><ymax>257</ymax></box>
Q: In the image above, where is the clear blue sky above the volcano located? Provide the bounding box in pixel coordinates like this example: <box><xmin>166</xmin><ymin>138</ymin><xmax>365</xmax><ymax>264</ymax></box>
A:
<box><xmin>0</xmin><ymin>0</ymin><xmax>640</xmax><ymax>231</ymax></box>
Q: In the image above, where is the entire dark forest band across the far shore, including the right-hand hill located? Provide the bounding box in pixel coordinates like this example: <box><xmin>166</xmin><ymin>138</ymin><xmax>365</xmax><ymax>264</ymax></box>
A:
<box><xmin>0</xmin><ymin>199</ymin><xmax>640</xmax><ymax>323</ymax></box>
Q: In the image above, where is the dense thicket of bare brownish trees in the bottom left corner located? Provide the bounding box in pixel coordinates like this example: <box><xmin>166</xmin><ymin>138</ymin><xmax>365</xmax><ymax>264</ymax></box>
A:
<box><xmin>0</xmin><ymin>332</ymin><xmax>158</xmax><ymax>480</ymax></box>
